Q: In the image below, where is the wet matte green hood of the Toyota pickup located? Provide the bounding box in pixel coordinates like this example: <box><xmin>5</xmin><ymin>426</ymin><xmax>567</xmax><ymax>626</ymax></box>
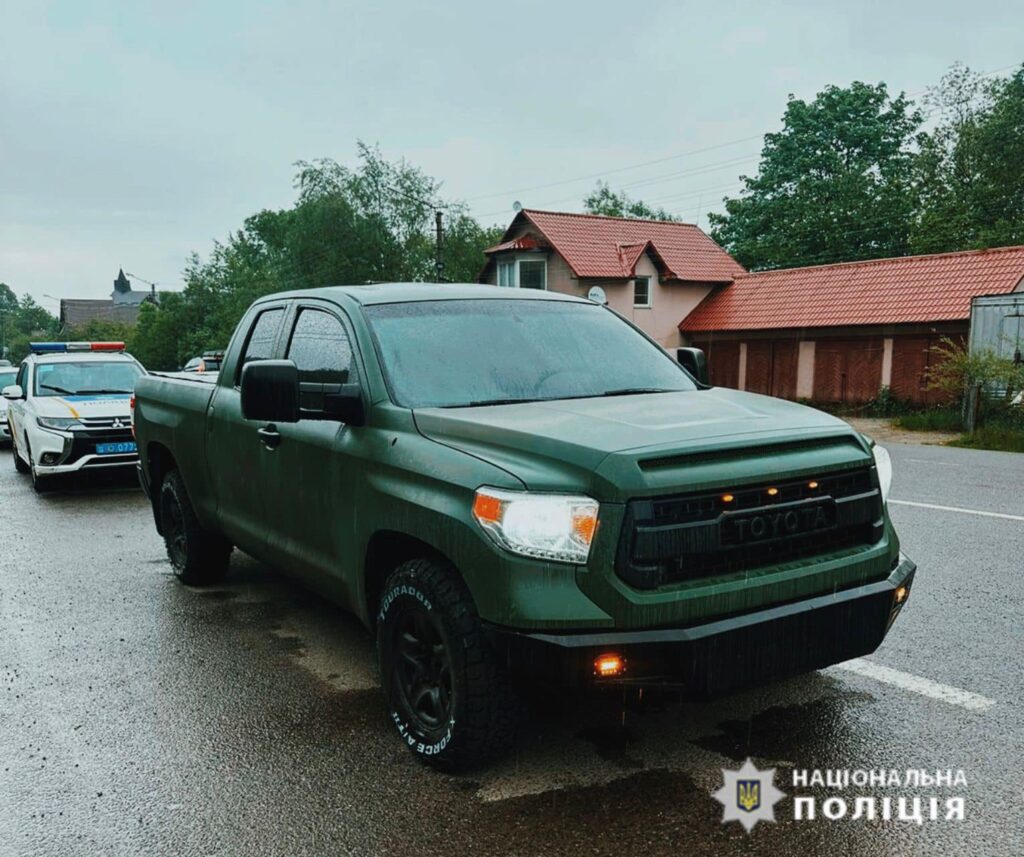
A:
<box><xmin>415</xmin><ymin>388</ymin><xmax>870</xmax><ymax>502</ymax></box>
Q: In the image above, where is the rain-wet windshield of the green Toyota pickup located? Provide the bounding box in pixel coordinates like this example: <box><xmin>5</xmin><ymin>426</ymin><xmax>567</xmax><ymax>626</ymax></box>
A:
<box><xmin>365</xmin><ymin>299</ymin><xmax>696</xmax><ymax>408</ymax></box>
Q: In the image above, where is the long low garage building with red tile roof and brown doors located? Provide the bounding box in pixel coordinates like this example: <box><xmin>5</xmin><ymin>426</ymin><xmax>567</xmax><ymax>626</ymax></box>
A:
<box><xmin>679</xmin><ymin>247</ymin><xmax>1024</xmax><ymax>403</ymax></box>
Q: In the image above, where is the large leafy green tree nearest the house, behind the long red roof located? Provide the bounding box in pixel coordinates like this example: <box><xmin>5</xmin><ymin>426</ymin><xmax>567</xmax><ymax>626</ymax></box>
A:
<box><xmin>711</xmin><ymin>82</ymin><xmax>922</xmax><ymax>269</ymax></box>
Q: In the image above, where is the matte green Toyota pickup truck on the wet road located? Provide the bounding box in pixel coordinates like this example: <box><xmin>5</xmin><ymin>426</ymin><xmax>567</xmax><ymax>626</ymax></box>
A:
<box><xmin>134</xmin><ymin>284</ymin><xmax>914</xmax><ymax>770</ymax></box>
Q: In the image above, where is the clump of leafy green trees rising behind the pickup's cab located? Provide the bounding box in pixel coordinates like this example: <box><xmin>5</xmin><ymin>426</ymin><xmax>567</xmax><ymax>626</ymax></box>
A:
<box><xmin>122</xmin><ymin>142</ymin><xmax>501</xmax><ymax>371</ymax></box>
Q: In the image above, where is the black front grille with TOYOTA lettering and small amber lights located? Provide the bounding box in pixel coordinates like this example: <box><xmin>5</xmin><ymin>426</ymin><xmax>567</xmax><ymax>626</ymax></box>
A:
<box><xmin>615</xmin><ymin>468</ymin><xmax>883</xmax><ymax>589</ymax></box>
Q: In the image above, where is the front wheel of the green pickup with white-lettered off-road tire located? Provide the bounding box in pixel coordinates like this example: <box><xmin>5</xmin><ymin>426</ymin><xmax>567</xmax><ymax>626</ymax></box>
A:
<box><xmin>377</xmin><ymin>559</ymin><xmax>518</xmax><ymax>772</ymax></box>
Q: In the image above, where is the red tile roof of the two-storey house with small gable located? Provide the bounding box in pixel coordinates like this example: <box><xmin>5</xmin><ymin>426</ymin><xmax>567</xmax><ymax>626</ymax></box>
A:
<box><xmin>506</xmin><ymin>209</ymin><xmax>743</xmax><ymax>283</ymax></box>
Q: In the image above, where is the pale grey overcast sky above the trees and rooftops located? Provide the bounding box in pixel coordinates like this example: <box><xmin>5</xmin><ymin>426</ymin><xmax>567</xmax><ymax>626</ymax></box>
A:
<box><xmin>0</xmin><ymin>0</ymin><xmax>1024</xmax><ymax>311</ymax></box>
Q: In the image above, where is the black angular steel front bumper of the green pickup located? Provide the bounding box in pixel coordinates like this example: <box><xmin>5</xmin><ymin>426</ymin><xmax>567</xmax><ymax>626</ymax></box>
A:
<box><xmin>487</xmin><ymin>555</ymin><xmax>916</xmax><ymax>699</ymax></box>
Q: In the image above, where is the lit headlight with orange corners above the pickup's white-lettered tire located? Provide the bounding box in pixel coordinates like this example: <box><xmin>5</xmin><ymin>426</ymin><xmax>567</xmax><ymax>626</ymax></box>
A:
<box><xmin>473</xmin><ymin>487</ymin><xmax>598</xmax><ymax>564</ymax></box>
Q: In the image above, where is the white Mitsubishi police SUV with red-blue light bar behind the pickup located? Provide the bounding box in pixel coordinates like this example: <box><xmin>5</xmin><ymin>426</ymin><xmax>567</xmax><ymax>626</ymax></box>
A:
<box><xmin>2</xmin><ymin>342</ymin><xmax>145</xmax><ymax>490</ymax></box>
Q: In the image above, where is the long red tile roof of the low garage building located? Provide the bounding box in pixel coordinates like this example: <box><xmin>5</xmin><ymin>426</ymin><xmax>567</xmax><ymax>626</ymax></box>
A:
<box><xmin>679</xmin><ymin>247</ymin><xmax>1024</xmax><ymax>333</ymax></box>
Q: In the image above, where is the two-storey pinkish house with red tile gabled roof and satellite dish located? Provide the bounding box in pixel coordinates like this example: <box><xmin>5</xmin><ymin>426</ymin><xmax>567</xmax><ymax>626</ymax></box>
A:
<box><xmin>479</xmin><ymin>209</ymin><xmax>743</xmax><ymax>347</ymax></box>
